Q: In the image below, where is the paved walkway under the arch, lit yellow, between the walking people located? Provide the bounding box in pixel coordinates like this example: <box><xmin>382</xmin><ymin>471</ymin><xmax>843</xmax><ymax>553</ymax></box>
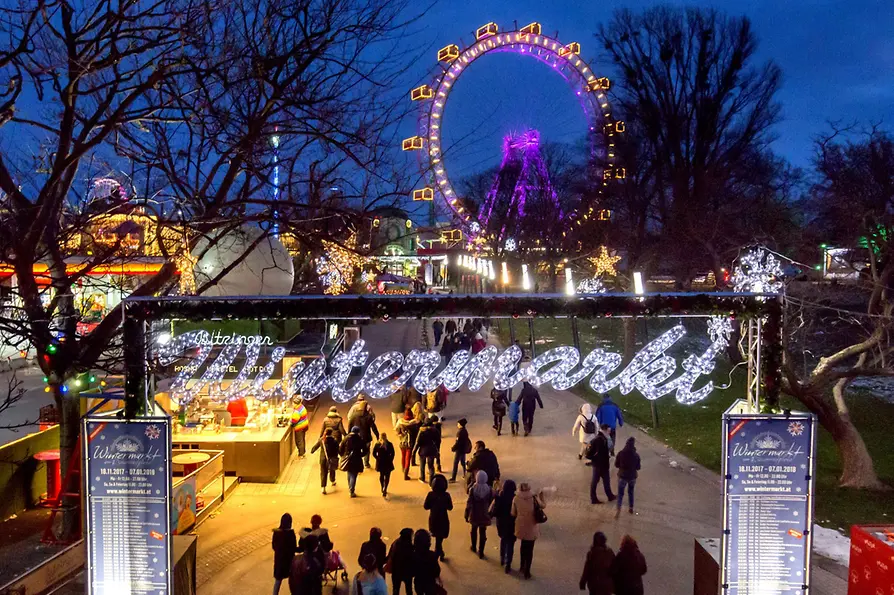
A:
<box><xmin>197</xmin><ymin>321</ymin><xmax>846</xmax><ymax>595</ymax></box>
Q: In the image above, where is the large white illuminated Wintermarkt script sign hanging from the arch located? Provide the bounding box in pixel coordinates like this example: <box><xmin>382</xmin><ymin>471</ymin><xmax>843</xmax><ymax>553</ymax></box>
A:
<box><xmin>158</xmin><ymin>317</ymin><xmax>732</xmax><ymax>404</ymax></box>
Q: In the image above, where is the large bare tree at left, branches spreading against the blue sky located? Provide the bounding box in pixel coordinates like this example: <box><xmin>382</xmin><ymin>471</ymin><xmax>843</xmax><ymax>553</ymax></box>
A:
<box><xmin>0</xmin><ymin>0</ymin><xmax>420</xmax><ymax>536</ymax></box>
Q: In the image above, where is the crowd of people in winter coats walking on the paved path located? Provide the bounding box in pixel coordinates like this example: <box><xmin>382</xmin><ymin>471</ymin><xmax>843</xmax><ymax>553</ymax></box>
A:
<box><xmin>272</xmin><ymin>320</ymin><xmax>646</xmax><ymax>595</ymax></box>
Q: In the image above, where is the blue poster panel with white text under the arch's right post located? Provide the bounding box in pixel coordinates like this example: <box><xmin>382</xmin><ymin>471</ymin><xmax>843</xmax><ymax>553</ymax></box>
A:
<box><xmin>722</xmin><ymin>413</ymin><xmax>816</xmax><ymax>595</ymax></box>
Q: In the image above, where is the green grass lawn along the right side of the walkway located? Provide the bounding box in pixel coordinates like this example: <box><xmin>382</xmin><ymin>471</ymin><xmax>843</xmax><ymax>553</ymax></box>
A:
<box><xmin>497</xmin><ymin>319</ymin><xmax>894</xmax><ymax>533</ymax></box>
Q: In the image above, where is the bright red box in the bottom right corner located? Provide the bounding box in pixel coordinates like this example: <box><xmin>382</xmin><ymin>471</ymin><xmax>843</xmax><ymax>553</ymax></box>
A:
<box><xmin>847</xmin><ymin>525</ymin><xmax>894</xmax><ymax>595</ymax></box>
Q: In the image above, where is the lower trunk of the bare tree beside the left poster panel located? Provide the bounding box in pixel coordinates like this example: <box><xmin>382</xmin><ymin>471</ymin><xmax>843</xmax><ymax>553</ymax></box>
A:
<box><xmin>53</xmin><ymin>385</ymin><xmax>83</xmax><ymax>541</ymax></box>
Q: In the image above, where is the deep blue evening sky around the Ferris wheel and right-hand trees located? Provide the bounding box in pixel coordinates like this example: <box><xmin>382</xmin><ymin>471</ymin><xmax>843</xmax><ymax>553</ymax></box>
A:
<box><xmin>405</xmin><ymin>0</ymin><xmax>894</xmax><ymax>182</ymax></box>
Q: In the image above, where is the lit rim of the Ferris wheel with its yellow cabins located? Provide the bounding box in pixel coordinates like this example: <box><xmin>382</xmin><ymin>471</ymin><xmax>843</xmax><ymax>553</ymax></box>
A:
<box><xmin>402</xmin><ymin>22</ymin><xmax>626</xmax><ymax>230</ymax></box>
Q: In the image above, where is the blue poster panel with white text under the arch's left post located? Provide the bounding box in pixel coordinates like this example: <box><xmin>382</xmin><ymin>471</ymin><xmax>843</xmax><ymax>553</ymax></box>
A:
<box><xmin>82</xmin><ymin>417</ymin><xmax>173</xmax><ymax>595</ymax></box>
